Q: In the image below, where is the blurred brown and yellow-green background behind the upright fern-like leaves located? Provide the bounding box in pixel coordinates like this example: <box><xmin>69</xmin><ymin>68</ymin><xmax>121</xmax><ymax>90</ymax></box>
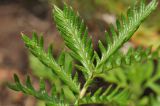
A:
<box><xmin>0</xmin><ymin>0</ymin><xmax>160</xmax><ymax>106</ymax></box>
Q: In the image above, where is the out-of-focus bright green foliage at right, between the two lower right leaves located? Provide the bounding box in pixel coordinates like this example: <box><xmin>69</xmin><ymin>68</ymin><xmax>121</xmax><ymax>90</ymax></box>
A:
<box><xmin>99</xmin><ymin>50</ymin><xmax>160</xmax><ymax>92</ymax></box>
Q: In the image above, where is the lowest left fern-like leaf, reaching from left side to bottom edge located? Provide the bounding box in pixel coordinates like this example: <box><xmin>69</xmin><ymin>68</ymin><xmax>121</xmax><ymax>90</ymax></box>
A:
<box><xmin>8</xmin><ymin>74</ymin><xmax>69</xmax><ymax>106</ymax></box>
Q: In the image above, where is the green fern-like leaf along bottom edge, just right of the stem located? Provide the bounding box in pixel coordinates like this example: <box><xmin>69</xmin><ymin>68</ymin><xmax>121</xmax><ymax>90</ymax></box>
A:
<box><xmin>80</xmin><ymin>86</ymin><xmax>129</xmax><ymax>105</ymax></box>
